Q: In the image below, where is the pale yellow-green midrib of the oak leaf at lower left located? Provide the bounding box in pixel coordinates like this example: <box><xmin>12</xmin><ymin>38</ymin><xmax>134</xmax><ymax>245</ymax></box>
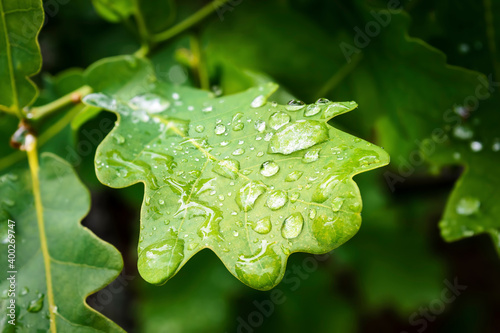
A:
<box><xmin>26</xmin><ymin>134</ymin><xmax>56</xmax><ymax>333</ymax></box>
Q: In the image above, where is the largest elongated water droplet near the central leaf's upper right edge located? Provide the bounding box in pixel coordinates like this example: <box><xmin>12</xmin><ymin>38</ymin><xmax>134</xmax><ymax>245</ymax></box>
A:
<box><xmin>269</xmin><ymin>120</ymin><xmax>329</xmax><ymax>155</ymax></box>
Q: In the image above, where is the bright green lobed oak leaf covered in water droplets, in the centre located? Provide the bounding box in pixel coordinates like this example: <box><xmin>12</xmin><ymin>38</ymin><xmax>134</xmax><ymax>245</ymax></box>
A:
<box><xmin>84</xmin><ymin>77</ymin><xmax>389</xmax><ymax>290</ymax></box>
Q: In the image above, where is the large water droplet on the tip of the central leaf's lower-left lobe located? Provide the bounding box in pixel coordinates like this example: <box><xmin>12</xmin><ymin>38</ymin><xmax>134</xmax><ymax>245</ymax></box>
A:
<box><xmin>137</xmin><ymin>238</ymin><xmax>184</xmax><ymax>284</ymax></box>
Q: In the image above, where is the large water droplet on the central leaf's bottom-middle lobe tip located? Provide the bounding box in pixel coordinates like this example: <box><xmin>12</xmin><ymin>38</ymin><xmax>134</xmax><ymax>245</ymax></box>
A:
<box><xmin>235</xmin><ymin>240</ymin><xmax>281</xmax><ymax>290</ymax></box>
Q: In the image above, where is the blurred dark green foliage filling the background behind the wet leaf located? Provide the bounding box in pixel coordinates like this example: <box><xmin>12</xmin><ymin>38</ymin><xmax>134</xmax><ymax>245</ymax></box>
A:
<box><xmin>0</xmin><ymin>0</ymin><xmax>500</xmax><ymax>333</ymax></box>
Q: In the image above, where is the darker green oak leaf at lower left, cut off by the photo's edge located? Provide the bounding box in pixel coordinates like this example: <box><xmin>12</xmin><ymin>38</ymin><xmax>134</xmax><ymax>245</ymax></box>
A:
<box><xmin>0</xmin><ymin>153</ymin><xmax>123</xmax><ymax>332</ymax></box>
